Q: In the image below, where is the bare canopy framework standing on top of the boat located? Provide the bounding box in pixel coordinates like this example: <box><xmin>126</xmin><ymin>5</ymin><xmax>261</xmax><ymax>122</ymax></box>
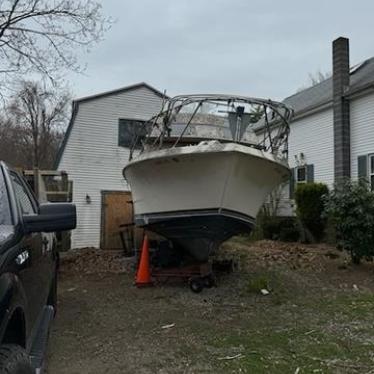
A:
<box><xmin>129</xmin><ymin>94</ymin><xmax>293</xmax><ymax>160</ymax></box>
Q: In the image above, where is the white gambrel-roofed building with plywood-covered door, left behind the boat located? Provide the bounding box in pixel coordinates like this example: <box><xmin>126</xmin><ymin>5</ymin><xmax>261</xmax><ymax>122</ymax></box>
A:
<box><xmin>56</xmin><ymin>83</ymin><xmax>164</xmax><ymax>249</ymax></box>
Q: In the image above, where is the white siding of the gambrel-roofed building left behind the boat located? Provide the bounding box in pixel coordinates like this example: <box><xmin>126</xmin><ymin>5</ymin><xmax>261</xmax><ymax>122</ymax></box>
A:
<box><xmin>58</xmin><ymin>86</ymin><xmax>162</xmax><ymax>248</ymax></box>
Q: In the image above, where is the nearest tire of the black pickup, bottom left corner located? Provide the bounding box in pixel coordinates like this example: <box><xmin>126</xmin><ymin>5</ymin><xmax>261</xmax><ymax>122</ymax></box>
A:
<box><xmin>0</xmin><ymin>344</ymin><xmax>35</xmax><ymax>374</ymax></box>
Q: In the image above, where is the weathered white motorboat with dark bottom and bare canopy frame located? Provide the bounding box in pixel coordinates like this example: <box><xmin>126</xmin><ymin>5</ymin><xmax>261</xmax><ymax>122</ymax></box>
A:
<box><xmin>123</xmin><ymin>95</ymin><xmax>292</xmax><ymax>262</ymax></box>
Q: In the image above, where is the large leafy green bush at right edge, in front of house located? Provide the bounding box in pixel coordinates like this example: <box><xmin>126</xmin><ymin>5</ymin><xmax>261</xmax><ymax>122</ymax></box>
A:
<box><xmin>325</xmin><ymin>180</ymin><xmax>374</xmax><ymax>263</ymax></box>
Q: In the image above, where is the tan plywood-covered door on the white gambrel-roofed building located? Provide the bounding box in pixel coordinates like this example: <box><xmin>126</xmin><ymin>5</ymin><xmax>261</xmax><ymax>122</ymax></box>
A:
<box><xmin>101</xmin><ymin>191</ymin><xmax>133</xmax><ymax>249</ymax></box>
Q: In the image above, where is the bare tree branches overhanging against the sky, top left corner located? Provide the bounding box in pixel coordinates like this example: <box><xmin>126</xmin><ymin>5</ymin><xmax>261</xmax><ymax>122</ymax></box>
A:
<box><xmin>0</xmin><ymin>0</ymin><xmax>111</xmax><ymax>88</ymax></box>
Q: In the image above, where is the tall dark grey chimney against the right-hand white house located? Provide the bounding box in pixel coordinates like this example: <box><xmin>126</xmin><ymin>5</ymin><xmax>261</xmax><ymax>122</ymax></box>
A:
<box><xmin>332</xmin><ymin>37</ymin><xmax>351</xmax><ymax>182</ymax></box>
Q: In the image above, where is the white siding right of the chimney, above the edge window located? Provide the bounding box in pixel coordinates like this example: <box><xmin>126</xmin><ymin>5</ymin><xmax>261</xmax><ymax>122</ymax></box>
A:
<box><xmin>350</xmin><ymin>94</ymin><xmax>374</xmax><ymax>179</ymax></box>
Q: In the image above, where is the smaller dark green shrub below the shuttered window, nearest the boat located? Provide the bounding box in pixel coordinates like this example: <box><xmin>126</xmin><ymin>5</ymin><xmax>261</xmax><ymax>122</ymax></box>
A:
<box><xmin>295</xmin><ymin>183</ymin><xmax>329</xmax><ymax>241</ymax></box>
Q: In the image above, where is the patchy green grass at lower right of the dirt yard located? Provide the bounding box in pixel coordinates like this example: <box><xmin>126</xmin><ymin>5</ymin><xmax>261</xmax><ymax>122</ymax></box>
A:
<box><xmin>199</xmin><ymin>238</ymin><xmax>374</xmax><ymax>374</ymax></box>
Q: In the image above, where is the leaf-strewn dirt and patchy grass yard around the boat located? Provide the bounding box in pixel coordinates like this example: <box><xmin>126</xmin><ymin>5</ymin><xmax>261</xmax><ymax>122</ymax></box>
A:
<box><xmin>47</xmin><ymin>239</ymin><xmax>374</xmax><ymax>374</ymax></box>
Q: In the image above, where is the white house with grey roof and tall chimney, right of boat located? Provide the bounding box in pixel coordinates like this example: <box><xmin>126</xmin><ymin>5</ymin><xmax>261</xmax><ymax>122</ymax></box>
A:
<box><xmin>279</xmin><ymin>37</ymin><xmax>374</xmax><ymax>215</ymax></box>
